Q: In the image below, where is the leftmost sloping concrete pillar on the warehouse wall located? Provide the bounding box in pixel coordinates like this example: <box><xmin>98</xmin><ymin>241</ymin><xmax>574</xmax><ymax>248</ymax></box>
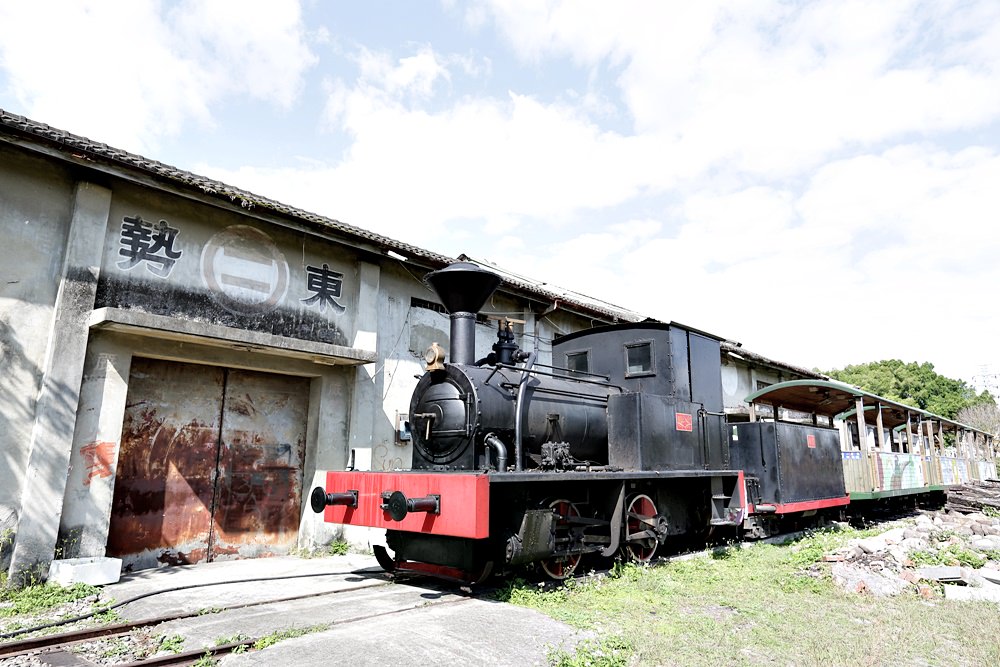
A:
<box><xmin>10</xmin><ymin>183</ymin><xmax>111</xmax><ymax>586</ymax></box>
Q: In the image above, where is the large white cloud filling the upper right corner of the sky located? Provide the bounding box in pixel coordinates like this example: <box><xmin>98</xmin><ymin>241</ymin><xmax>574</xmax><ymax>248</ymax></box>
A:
<box><xmin>477</xmin><ymin>0</ymin><xmax>1000</xmax><ymax>177</ymax></box>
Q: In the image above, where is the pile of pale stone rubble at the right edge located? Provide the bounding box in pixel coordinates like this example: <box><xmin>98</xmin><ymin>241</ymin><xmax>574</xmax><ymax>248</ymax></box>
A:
<box><xmin>823</xmin><ymin>510</ymin><xmax>1000</xmax><ymax>603</ymax></box>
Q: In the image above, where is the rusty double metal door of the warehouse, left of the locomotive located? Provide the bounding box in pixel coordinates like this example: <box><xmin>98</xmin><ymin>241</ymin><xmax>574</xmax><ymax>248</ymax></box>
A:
<box><xmin>108</xmin><ymin>359</ymin><xmax>309</xmax><ymax>570</ymax></box>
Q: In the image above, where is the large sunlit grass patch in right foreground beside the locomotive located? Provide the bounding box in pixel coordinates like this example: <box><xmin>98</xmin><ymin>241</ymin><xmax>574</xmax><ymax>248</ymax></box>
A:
<box><xmin>508</xmin><ymin>530</ymin><xmax>1000</xmax><ymax>667</ymax></box>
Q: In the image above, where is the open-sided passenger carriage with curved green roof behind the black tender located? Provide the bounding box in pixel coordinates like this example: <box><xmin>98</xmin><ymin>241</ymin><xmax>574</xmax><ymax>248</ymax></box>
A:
<box><xmin>732</xmin><ymin>380</ymin><xmax>997</xmax><ymax>532</ymax></box>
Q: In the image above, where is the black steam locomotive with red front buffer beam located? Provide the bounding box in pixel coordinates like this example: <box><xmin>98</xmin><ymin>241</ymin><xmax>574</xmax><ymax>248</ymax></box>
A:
<box><xmin>310</xmin><ymin>262</ymin><xmax>847</xmax><ymax>581</ymax></box>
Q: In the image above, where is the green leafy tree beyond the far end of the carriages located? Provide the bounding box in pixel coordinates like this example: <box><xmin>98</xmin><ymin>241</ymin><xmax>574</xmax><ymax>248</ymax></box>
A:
<box><xmin>826</xmin><ymin>359</ymin><xmax>996</xmax><ymax>419</ymax></box>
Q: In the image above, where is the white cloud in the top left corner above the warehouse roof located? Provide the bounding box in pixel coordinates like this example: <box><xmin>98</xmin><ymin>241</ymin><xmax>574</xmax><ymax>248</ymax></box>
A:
<box><xmin>0</xmin><ymin>0</ymin><xmax>314</xmax><ymax>151</ymax></box>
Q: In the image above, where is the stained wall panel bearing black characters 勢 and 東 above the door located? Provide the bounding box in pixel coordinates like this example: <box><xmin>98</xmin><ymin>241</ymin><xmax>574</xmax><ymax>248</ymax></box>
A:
<box><xmin>97</xmin><ymin>185</ymin><xmax>358</xmax><ymax>346</ymax></box>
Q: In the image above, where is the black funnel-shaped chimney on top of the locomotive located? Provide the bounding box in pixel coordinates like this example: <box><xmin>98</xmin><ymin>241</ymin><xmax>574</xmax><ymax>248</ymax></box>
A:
<box><xmin>424</xmin><ymin>262</ymin><xmax>500</xmax><ymax>364</ymax></box>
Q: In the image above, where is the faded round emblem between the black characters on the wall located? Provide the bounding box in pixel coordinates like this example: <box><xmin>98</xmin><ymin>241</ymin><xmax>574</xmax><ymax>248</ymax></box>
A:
<box><xmin>201</xmin><ymin>225</ymin><xmax>288</xmax><ymax>315</ymax></box>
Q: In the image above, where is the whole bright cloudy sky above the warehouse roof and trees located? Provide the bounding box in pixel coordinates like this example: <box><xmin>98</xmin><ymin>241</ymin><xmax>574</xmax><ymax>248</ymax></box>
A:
<box><xmin>0</xmin><ymin>0</ymin><xmax>1000</xmax><ymax>382</ymax></box>
